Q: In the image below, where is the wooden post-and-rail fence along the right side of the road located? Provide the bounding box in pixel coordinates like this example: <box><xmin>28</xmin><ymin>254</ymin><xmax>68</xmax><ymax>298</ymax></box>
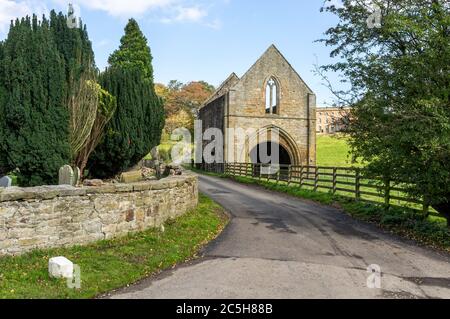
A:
<box><xmin>201</xmin><ymin>163</ymin><xmax>429</xmax><ymax>213</ymax></box>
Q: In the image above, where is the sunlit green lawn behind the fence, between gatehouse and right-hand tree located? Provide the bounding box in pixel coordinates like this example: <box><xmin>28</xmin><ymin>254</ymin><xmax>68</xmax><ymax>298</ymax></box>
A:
<box><xmin>317</xmin><ymin>135</ymin><xmax>360</xmax><ymax>167</ymax></box>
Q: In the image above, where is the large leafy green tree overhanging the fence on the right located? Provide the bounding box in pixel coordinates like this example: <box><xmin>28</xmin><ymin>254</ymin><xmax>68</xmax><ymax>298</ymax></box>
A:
<box><xmin>322</xmin><ymin>0</ymin><xmax>450</xmax><ymax>221</ymax></box>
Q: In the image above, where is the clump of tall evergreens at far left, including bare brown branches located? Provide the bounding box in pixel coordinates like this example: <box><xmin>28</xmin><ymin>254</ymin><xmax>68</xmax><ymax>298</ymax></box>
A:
<box><xmin>0</xmin><ymin>11</ymin><xmax>115</xmax><ymax>186</ymax></box>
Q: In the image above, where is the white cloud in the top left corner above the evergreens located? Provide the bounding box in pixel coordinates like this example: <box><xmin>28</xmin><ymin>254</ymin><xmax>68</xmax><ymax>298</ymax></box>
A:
<box><xmin>0</xmin><ymin>0</ymin><xmax>48</xmax><ymax>33</ymax></box>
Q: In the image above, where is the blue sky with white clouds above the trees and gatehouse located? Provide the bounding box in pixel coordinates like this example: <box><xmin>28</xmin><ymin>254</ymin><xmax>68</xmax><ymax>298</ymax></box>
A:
<box><xmin>0</xmin><ymin>0</ymin><xmax>344</xmax><ymax>106</ymax></box>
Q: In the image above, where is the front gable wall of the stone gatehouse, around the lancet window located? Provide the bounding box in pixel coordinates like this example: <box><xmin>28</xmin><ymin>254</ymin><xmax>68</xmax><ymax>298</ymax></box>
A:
<box><xmin>228</xmin><ymin>46</ymin><xmax>316</xmax><ymax>165</ymax></box>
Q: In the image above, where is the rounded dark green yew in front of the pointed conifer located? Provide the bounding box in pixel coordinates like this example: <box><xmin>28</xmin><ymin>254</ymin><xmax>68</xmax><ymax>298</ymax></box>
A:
<box><xmin>88</xmin><ymin>67</ymin><xmax>164</xmax><ymax>178</ymax></box>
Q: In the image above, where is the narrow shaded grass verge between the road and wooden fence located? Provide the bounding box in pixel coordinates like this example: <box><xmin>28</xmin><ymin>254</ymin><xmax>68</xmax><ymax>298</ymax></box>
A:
<box><xmin>194</xmin><ymin>170</ymin><xmax>450</xmax><ymax>252</ymax></box>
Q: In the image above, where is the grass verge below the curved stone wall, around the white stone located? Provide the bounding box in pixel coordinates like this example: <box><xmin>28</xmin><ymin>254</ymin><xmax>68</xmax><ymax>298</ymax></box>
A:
<box><xmin>0</xmin><ymin>195</ymin><xmax>228</xmax><ymax>299</ymax></box>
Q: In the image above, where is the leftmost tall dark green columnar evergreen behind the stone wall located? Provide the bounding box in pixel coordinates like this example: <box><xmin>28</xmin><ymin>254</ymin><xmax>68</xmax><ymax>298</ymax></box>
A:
<box><xmin>1</xmin><ymin>16</ymin><xmax>69</xmax><ymax>186</ymax></box>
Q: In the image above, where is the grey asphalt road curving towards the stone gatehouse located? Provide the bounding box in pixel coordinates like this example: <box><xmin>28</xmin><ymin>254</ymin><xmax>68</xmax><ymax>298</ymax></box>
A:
<box><xmin>109</xmin><ymin>176</ymin><xmax>450</xmax><ymax>299</ymax></box>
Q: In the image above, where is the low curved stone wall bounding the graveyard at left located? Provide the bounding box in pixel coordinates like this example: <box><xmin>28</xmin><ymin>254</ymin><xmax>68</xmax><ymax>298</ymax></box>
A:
<box><xmin>0</xmin><ymin>173</ymin><xmax>198</xmax><ymax>255</ymax></box>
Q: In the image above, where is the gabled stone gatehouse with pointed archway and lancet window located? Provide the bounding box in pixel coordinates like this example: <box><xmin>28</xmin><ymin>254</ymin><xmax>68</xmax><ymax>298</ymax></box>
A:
<box><xmin>199</xmin><ymin>45</ymin><xmax>316</xmax><ymax>166</ymax></box>
